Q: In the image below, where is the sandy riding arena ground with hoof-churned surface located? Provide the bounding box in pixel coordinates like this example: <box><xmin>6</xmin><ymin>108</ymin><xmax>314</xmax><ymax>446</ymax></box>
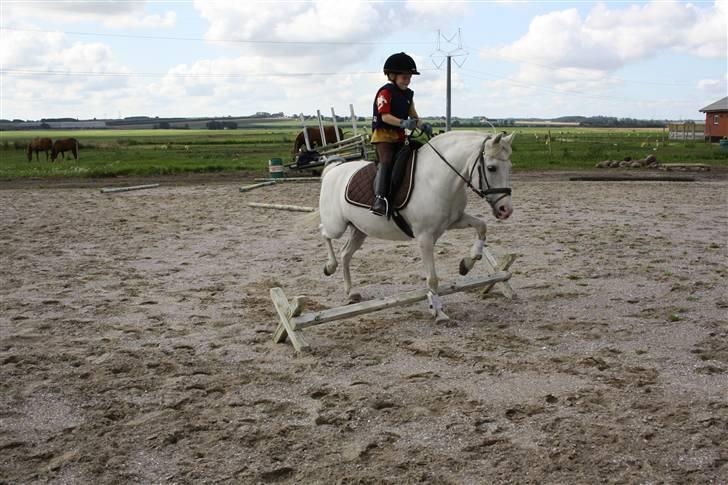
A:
<box><xmin>0</xmin><ymin>169</ymin><xmax>728</xmax><ymax>484</ymax></box>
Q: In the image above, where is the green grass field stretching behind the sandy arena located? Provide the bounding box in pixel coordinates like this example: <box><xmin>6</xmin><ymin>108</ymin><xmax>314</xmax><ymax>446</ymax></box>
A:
<box><xmin>0</xmin><ymin>124</ymin><xmax>728</xmax><ymax>179</ymax></box>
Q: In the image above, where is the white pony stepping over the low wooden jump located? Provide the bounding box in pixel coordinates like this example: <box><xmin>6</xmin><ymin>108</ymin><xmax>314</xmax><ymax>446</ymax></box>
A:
<box><xmin>319</xmin><ymin>131</ymin><xmax>514</xmax><ymax>320</ymax></box>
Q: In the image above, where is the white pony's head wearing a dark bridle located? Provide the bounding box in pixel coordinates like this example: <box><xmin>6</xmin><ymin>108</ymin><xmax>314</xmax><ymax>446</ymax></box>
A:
<box><xmin>480</xmin><ymin>133</ymin><xmax>515</xmax><ymax>220</ymax></box>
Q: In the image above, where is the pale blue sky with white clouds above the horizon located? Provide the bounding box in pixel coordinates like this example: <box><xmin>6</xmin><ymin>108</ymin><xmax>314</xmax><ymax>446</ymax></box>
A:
<box><xmin>0</xmin><ymin>0</ymin><xmax>728</xmax><ymax>119</ymax></box>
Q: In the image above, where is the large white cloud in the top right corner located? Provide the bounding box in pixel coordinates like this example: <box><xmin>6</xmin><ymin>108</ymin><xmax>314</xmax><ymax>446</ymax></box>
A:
<box><xmin>481</xmin><ymin>1</ymin><xmax>728</xmax><ymax>83</ymax></box>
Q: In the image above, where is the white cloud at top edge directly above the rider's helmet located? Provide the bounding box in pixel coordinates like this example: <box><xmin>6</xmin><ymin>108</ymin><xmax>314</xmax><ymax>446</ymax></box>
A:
<box><xmin>194</xmin><ymin>0</ymin><xmax>465</xmax><ymax>70</ymax></box>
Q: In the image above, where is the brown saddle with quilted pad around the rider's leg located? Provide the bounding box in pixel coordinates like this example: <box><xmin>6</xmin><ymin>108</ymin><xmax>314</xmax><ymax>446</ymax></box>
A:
<box><xmin>345</xmin><ymin>147</ymin><xmax>417</xmax><ymax>211</ymax></box>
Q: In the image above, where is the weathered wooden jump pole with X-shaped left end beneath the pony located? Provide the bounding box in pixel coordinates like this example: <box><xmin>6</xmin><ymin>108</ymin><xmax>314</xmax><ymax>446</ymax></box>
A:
<box><xmin>270</xmin><ymin>271</ymin><xmax>511</xmax><ymax>352</ymax></box>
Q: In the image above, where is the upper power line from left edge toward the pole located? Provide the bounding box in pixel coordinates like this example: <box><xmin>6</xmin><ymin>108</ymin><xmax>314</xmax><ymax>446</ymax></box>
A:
<box><xmin>0</xmin><ymin>27</ymin><xmax>432</xmax><ymax>45</ymax></box>
